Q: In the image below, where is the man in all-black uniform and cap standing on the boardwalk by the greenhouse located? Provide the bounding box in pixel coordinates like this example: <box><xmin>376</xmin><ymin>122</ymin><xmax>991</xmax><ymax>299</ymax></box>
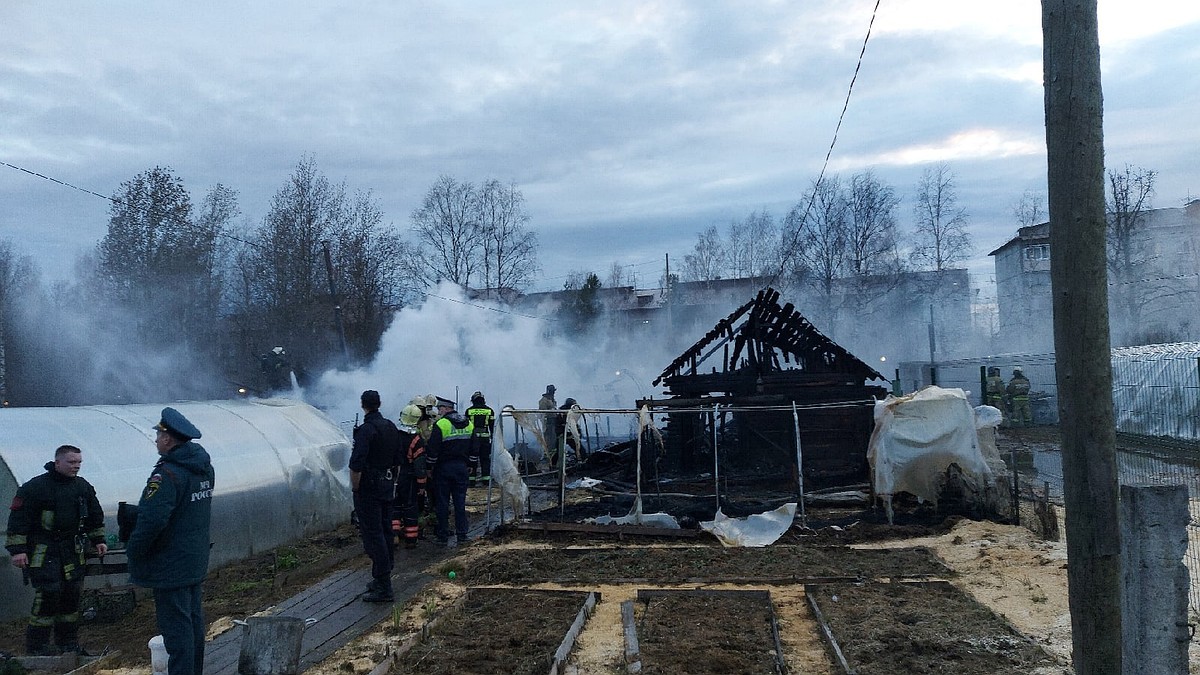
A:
<box><xmin>350</xmin><ymin>389</ymin><xmax>401</xmax><ymax>603</ymax></box>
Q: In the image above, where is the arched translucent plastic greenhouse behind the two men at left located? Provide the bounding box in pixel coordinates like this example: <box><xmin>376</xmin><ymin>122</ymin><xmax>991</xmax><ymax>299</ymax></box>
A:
<box><xmin>0</xmin><ymin>399</ymin><xmax>353</xmax><ymax>617</ymax></box>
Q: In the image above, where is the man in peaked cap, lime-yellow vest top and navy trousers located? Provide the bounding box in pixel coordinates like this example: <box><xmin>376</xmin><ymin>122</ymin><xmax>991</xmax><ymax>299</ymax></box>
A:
<box><xmin>425</xmin><ymin>396</ymin><xmax>479</xmax><ymax>548</ymax></box>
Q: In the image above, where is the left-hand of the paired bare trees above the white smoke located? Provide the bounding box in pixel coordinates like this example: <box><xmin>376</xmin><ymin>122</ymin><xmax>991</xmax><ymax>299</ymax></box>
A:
<box><xmin>412</xmin><ymin>175</ymin><xmax>486</xmax><ymax>288</ymax></box>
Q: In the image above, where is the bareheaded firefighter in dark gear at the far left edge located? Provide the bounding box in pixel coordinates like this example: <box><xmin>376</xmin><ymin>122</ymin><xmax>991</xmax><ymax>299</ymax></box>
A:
<box><xmin>5</xmin><ymin>446</ymin><xmax>108</xmax><ymax>656</ymax></box>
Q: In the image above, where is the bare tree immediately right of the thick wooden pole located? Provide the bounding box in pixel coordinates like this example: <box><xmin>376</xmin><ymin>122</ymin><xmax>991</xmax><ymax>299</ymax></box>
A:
<box><xmin>1104</xmin><ymin>165</ymin><xmax>1156</xmax><ymax>345</ymax></box>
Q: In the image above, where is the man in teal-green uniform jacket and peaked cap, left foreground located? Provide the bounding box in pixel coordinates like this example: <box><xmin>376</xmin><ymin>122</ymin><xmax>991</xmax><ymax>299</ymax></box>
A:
<box><xmin>125</xmin><ymin>407</ymin><xmax>215</xmax><ymax>675</ymax></box>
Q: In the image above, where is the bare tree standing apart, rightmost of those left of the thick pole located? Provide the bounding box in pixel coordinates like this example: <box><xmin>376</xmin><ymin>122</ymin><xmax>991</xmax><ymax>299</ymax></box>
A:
<box><xmin>912</xmin><ymin>163</ymin><xmax>971</xmax><ymax>271</ymax></box>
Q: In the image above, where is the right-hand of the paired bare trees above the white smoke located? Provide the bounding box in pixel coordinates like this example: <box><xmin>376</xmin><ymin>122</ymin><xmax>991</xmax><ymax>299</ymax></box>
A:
<box><xmin>478</xmin><ymin>179</ymin><xmax>540</xmax><ymax>289</ymax></box>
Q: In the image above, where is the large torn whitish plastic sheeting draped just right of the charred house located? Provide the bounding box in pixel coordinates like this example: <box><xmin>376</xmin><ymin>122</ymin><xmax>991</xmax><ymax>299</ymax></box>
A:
<box><xmin>868</xmin><ymin>387</ymin><xmax>992</xmax><ymax>503</ymax></box>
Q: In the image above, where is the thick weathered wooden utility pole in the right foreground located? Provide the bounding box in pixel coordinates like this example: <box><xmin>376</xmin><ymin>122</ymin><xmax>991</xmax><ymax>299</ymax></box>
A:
<box><xmin>1042</xmin><ymin>0</ymin><xmax>1122</xmax><ymax>675</ymax></box>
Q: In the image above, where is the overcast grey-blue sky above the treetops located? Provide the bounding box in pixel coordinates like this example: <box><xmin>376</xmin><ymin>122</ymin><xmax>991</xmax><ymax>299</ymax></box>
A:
<box><xmin>0</xmin><ymin>0</ymin><xmax>1200</xmax><ymax>289</ymax></box>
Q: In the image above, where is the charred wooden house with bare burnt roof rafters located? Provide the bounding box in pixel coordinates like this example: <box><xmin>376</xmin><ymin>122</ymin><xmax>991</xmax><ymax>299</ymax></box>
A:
<box><xmin>642</xmin><ymin>288</ymin><xmax>887</xmax><ymax>489</ymax></box>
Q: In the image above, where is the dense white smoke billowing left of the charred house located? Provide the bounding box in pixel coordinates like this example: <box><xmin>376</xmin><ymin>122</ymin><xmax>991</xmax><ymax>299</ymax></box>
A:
<box><xmin>305</xmin><ymin>283</ymin><xmax>674</xmax><ymax>422</ymax></box>
